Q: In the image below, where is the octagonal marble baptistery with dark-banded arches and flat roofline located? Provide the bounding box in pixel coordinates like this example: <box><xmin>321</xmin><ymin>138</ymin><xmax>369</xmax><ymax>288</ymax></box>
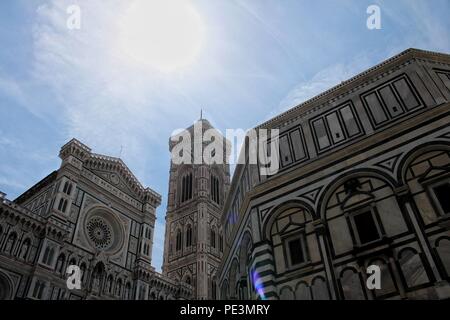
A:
<box><xmin>217</xmin><ymin>49</ymin><xmax>450</xmax><ymax>300</ymax></box>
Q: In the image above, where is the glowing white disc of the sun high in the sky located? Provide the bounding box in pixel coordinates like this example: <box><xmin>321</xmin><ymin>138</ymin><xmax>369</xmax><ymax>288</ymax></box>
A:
<box><xmin>119</xmin><ymin>0</ymin><xmax>204</xmax><ymax>72</ymax></box>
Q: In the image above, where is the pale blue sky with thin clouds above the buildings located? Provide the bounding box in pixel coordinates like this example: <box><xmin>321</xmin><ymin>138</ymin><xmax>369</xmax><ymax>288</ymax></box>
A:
<box><xmin>0</xmin><ymin>0</ymin><xmax>450</xmax><ymax>270</ymax></box>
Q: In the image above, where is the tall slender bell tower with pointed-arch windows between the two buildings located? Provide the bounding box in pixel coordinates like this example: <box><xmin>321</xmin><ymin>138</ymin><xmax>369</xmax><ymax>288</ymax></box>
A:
<box><xmin>163</xmin><ymin>119</ymin><xmax>230</xmax><ymax>300</ymax></box>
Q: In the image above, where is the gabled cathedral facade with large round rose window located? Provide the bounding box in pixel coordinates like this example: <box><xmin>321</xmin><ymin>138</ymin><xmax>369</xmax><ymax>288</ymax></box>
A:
<box><xmin>0</xmin><ymin>139</ymin><xmax>192</xmax><ymax>300</ymax></box>
